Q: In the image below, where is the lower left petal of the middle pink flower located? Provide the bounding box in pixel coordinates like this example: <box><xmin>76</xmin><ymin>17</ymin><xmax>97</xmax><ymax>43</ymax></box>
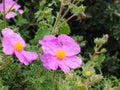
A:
<box><xmin>41</xmin><ymin>54</ymin><xmax>58</xmax><ymax>70</ymax></box>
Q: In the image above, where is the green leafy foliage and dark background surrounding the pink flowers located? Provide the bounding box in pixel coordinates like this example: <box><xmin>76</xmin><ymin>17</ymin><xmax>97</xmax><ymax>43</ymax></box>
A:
<box><xmin>0</xmin><ymin>0</ymin><xmax>120</xmax><ymax>90</ymax></box>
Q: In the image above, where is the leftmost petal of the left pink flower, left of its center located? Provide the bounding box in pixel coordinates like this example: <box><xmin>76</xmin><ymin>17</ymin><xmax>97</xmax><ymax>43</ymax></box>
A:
<box><xmin>2</xmin><ymin>37</ymin><xmax>14</xmax><ymax>55</ymax></box>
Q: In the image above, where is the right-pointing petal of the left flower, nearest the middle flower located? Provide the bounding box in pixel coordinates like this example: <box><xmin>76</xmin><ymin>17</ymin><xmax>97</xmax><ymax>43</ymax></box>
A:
<box><xmin>21</xmin><ymin>50</ymin><xmax>38</xmax><ymax>63</ymax></box>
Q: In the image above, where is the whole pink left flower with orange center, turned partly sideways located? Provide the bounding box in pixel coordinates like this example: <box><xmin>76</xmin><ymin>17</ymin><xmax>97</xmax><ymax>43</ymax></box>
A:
<box><xmin>2</xmin><ymin>28</ymin><xmax>38</xmax><ymax>65</ymax></box>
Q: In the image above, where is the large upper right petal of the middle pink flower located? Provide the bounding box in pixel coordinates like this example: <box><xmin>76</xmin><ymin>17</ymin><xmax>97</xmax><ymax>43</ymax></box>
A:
<box><xmin>58</xmin><ymin>34</ymin><xmax>80</xmax><ymax>56</ymax></box>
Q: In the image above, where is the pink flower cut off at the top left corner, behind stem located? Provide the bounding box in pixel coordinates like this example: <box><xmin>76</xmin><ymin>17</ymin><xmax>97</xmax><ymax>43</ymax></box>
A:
<box><xmin>0</xmin><ymin>0</ymin><xmax>23</xmax><ymax>19</ymax></box>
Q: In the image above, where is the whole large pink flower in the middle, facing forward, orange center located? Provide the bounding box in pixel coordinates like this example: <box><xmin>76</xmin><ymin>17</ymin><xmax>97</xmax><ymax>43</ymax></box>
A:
<box><xmin>39</xmin><ymin>34</ymin><xmax>82</xmax><ymax>73</ymax></box>
